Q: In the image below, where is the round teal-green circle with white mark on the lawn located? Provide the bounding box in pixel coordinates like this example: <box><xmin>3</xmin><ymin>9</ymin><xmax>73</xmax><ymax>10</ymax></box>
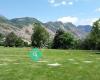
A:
<box><xmin>29</xmin><ymin>48</ymin><xmax>42</xmax><ymax>61</ymax></box>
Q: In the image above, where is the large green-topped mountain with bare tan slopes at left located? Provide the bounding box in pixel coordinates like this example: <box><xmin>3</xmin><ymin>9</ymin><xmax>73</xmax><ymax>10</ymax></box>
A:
<box><xmin>0</xmin><ymin>16</ymin><xmax>54</xmax><ymax>41</ymax></box>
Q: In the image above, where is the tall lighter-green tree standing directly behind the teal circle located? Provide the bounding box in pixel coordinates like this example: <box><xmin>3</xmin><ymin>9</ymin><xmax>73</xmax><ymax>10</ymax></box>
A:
<box><xmin>31</xmin><ymin>23</ymin><xmax>49</xmax><ymax>48</ymax></box>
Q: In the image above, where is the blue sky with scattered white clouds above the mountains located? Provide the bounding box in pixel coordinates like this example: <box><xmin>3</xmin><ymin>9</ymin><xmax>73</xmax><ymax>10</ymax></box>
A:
<box><xmin>0</xmin><ymin>0</ymin><xmax>100</xmax><ymax>25</ymax></box>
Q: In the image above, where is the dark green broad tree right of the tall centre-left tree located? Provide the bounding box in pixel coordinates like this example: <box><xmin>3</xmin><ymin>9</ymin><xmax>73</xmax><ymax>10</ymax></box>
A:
<box><xmin>53</xmin><ymin>29</ymin><xmax>74</xmax><ymax>49</ymax></box>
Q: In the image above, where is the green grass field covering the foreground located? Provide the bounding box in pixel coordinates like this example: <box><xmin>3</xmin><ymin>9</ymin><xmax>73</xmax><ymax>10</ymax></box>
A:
<box><xmin>0</xmin><ymin>47</ymin><xmax>100</xmax><ymax>80</ymax></box>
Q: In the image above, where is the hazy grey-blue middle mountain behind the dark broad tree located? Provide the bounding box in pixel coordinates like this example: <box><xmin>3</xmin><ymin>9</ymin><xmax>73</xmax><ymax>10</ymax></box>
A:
<box><xmin>44</xmin><ymin>22</ymin><xmax>86</xmax><ymax>38</ymax></box>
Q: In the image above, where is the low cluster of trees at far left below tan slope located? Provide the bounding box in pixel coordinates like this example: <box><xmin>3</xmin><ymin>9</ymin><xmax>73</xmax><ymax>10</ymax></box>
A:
<box><xmin>0</xmin><ymin>32</ymin><xmax>29</xmax><ymax>47</ymax></box>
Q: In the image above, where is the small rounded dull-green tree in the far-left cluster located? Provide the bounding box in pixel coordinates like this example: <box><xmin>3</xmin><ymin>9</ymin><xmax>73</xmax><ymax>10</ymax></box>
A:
<box><xmin>5</xmin><ymin>32</ymin><xmax>17</xmax><ymax>47</ymax></box>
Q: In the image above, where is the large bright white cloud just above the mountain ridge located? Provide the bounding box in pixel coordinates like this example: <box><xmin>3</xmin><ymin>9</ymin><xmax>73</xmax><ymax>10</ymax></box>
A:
<box><xmin>57</xmin><ymin>16</ymin><xmax>78</xmax><ymax>24</ymax></box>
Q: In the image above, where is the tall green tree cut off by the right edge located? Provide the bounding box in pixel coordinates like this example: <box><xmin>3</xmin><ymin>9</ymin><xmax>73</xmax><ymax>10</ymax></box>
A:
<box><xmin>82</xmin><ymin>19</ymin><xmax>100</xmax><ymax>50</ymax></box>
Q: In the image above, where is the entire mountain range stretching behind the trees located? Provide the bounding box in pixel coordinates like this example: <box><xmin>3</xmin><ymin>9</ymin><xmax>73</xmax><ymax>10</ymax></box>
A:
<box><xmin>0</xmin><ymin>16</ymin><xmax>91</xmax><ymax>42</ymax></box>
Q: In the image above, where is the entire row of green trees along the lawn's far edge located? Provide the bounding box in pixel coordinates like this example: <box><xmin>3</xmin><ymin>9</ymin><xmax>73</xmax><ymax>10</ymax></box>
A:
<box><xmin>0</xmin><ymin>19</ymin><xmax>100</xmax><ymax>50</ymax></box>
